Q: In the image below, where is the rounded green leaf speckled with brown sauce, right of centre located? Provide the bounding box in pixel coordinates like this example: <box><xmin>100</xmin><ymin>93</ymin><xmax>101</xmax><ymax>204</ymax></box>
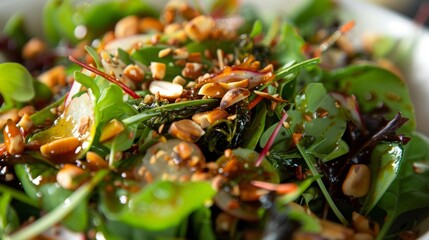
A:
<box><xmin>259</xmin><ymin>83</ymin><xmax>348</xmax><ymax>161</ymax></box>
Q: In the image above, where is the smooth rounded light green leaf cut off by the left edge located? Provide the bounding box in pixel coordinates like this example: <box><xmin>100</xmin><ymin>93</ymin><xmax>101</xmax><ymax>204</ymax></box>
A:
<box><xmin>0</xmin><ymin>62</ymin><xmax>35</xmax><ymax>105</ymax></box>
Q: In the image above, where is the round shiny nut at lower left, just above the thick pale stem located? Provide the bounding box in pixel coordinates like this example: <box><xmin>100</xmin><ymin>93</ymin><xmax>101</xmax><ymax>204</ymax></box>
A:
<box><xmin>57</xmin><ymin>164</ymin><xmax>85</xmax><ymax>190</ymax></box>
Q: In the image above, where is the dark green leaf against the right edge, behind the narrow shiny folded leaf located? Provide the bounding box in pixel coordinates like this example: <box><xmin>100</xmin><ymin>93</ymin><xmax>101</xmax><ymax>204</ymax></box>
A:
<box><xmin>377</xmin><ymin>133</ymin><xmax>429</xmax><ymax>239</ymax></box>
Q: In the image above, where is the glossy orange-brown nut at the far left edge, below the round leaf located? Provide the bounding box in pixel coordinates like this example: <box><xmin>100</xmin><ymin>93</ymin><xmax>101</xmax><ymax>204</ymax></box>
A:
<box><xmin>3</xmin><ymin>119</ymin><xmax>24</xmax><ymax>154</ymax></box>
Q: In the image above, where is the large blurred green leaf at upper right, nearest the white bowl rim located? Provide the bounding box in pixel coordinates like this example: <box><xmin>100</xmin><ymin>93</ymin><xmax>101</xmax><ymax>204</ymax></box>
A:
<box><xmin>327</xmin><ymin>64</ymin><xmax>416</xmax><ymax>133</ymax></box>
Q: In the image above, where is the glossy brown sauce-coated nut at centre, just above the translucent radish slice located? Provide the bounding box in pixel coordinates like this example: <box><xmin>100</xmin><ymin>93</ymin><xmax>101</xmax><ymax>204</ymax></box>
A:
<box><xmin>168</xmin><ymin>119</ymin><xmax>205</xmax><ymax>142</ymax></box>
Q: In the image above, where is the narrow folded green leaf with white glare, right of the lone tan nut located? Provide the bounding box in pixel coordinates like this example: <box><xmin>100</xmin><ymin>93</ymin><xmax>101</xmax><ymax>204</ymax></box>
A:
<box><xmin>361</xmin><ymin>143</ymin><xmax>403</xmax><ymax>215</ymax></box>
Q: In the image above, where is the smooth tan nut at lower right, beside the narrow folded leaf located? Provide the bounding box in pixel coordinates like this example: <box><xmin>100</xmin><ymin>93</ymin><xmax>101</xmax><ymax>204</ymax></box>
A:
<box><xmin>342</xmin><ymin>164</ymin><xmax>371</xmax><ymax>197</ymax></box>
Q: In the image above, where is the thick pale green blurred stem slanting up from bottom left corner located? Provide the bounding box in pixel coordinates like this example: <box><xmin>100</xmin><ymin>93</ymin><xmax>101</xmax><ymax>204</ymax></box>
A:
<box><xmin>5</xmin><ymin>170</ymin><xmax>109</xmax><ymax>240</ymax></box>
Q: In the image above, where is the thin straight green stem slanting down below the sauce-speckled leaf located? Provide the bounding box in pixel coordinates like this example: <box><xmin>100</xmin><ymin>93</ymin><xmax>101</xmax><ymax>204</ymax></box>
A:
<box><xmin>296</xmin><ymin>144</ymin><xmax>349</xmax><ymax>226</ymax></box>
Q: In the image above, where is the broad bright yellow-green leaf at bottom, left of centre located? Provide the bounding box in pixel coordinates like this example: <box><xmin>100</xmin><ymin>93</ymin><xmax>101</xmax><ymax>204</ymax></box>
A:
<box><xmin>118</xmin><ymin>181</ymin><xmax>215</xmax><ymax>230</ymax></box>
